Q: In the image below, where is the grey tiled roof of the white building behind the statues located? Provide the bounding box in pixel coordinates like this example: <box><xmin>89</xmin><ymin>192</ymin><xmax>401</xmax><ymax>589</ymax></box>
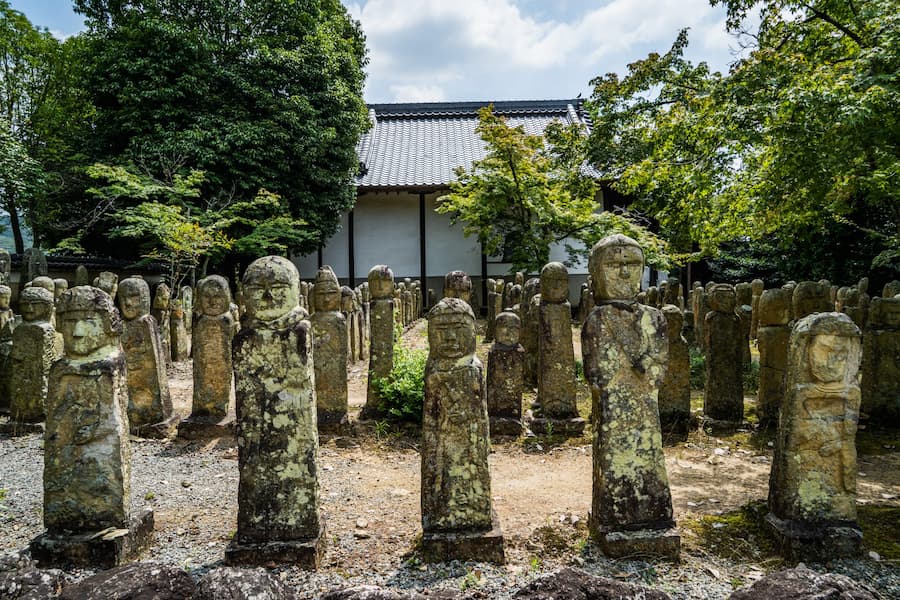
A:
<box><xmin>357</xmin><ymin>99</ymin><xmax>588</xmax><ymax>191</ymax></box>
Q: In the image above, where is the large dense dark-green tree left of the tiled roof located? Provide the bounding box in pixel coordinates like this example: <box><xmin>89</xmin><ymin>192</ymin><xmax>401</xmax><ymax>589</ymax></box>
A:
<box><xmin>58</xmin><ymin>0</ymin><xmax>368</xmax><ymax>256</ymax></box>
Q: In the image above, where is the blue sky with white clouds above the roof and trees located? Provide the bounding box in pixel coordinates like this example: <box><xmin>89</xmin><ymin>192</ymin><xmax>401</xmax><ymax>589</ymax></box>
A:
<box><xmin>8</xmin><ymin>0</ymin><xmax>748</xmax><ymax>102</ymax></box>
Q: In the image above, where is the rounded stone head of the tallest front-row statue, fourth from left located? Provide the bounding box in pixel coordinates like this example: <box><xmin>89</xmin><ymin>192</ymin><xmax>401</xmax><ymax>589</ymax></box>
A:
<box><xmin>588</xmin><ymin>233</ymin><xmax>644</xmax><ymax>302</ymax></box>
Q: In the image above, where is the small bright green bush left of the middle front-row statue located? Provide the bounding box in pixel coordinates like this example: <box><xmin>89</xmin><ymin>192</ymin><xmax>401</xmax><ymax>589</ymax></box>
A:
<box><xmin>373</xmin><ymin>338</ymin><xmax>428</xmax><ymax>423</ymax></box>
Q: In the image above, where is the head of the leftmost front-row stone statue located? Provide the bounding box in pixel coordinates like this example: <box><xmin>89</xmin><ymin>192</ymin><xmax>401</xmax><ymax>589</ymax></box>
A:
<box><xmin>57</xmin><ymin>285</ymin><xmax>122</xmax><ymax>357</ymax></box>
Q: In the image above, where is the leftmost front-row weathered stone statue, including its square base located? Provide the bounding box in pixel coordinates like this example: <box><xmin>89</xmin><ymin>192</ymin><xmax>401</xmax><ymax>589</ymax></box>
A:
<box><xmin>31</xmin><ymin>286</ymin><xmax>153</xmax><ymax>567</ymax></box>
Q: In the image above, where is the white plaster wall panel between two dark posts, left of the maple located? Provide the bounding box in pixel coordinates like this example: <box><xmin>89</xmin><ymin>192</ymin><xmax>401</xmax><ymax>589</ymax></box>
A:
<box><xmin>353</xmin><ymin>193</ymin><xmax>421</xmax><ymax>280</ymax></box>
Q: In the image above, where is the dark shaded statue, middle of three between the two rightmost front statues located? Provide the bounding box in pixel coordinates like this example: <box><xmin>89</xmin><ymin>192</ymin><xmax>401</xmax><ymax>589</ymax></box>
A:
<box><xmin>703</xmin><ymin>283</ymin><xmax>744</xmax><ymax>427</ymax></box>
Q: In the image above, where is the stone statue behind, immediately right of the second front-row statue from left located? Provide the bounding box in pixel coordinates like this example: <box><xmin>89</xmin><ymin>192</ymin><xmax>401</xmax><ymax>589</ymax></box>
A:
<box><xmin>310</xmin><ymin>266</ymin><xmax>348</xmax><ymax>431</ymax></box>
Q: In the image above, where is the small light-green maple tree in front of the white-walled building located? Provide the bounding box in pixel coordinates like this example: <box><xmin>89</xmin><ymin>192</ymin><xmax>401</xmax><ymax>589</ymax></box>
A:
<box><xmin>437</xmin><ymin>106</ymin><xmax>668</xmax><ymax>271</ymax></box>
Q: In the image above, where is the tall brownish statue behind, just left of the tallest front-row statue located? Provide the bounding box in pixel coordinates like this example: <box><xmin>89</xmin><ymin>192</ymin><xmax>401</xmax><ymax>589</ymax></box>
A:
<box><xmin>530</xmin><ymin>262</ymin><xmax>585</xmax><ymax>437</ymax></box>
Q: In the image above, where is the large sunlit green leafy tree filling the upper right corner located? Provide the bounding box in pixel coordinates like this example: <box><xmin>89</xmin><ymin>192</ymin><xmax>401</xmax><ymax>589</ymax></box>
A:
<box><xmin>590</xmin><ymin>0</ymin><xmax>900</xmax><ymax>282</ymax></box>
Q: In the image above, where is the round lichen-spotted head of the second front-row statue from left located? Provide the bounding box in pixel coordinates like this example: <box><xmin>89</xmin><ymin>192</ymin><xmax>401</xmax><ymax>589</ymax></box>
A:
<box><xmin>243</xmin><ymin>256</ymin><xmax>300</xmax><ymax>322</ymax></box>
